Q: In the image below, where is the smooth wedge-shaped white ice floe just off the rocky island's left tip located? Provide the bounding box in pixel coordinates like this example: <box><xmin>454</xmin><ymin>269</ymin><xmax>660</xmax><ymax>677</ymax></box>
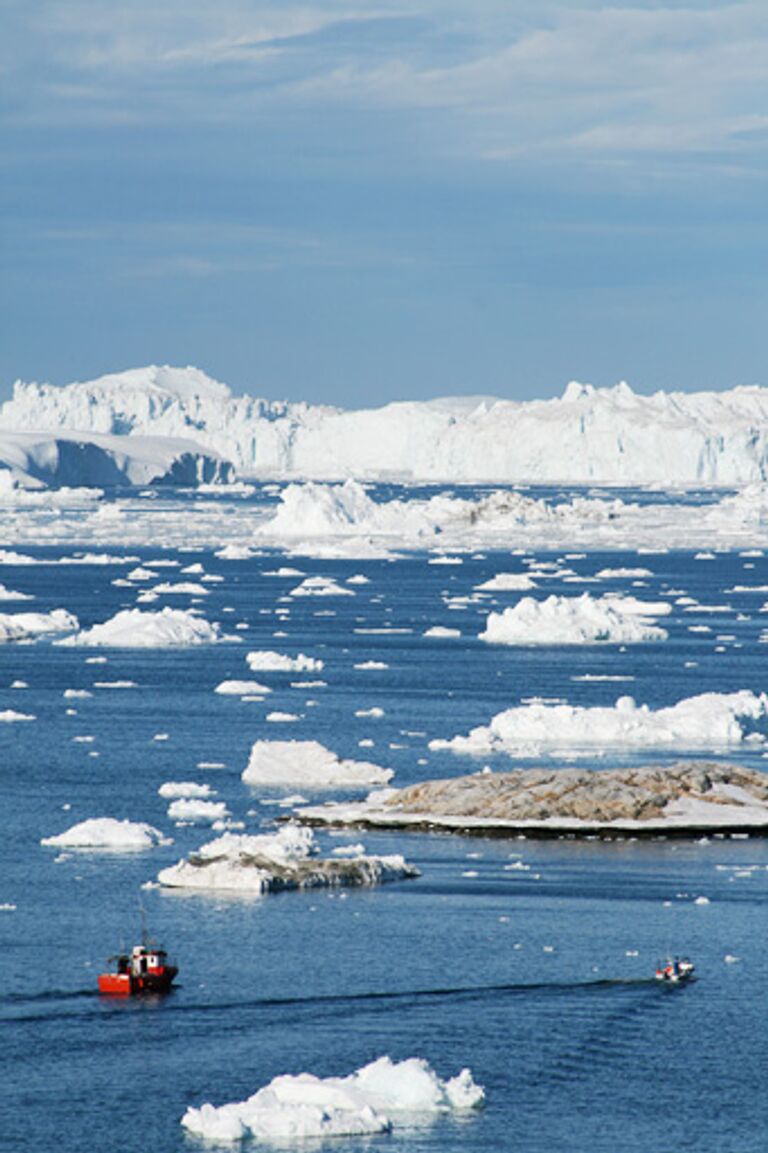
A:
<box><xmin>242</xmin><ymin>740</ymin><xmax>394</xmax><ymax>789</ymax></box>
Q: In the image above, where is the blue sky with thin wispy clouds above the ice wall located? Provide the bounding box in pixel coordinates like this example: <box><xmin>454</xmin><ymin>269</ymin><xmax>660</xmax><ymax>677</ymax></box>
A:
<box><xmin>0</xmin><ymin>0</ymin><xmax>768</xmax><ymax>407</ymax></box>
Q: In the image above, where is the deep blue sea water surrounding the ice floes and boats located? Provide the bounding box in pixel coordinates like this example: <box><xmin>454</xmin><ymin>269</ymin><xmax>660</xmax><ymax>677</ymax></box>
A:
<box><xmin>0</xmin><ymin>486</ymin><xmax>768</xmax><ymax>1153</ymax></box>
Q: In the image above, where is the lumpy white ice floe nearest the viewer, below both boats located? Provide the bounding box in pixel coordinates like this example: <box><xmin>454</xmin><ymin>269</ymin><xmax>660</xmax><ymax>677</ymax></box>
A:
<box><xmin>181</xmin><ymin>1057</ymin><xmax>485</xmax><ymax>1141</ymax></box>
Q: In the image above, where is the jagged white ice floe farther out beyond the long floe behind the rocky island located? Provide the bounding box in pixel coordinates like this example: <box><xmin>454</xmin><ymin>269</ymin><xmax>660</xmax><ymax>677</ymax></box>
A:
<box><xmin>480</xmin><ymin>593</ymin><xmax>670</xmax><ymax>645</ymax></box>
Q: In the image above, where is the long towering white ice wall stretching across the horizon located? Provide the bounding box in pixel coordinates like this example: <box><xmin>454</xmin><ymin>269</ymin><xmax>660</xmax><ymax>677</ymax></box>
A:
<box><xmin>0</xmin><ymin>366</ymin><xmax>768</xmax><ymax>484</ymax></box>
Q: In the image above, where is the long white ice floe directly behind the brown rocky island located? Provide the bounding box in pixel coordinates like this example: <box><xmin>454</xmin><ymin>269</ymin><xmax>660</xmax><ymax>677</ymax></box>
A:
<box><xmin>429</xmin><ymin>689</ymin><xmax>768</xmax><ymax>755</ymax></box>
